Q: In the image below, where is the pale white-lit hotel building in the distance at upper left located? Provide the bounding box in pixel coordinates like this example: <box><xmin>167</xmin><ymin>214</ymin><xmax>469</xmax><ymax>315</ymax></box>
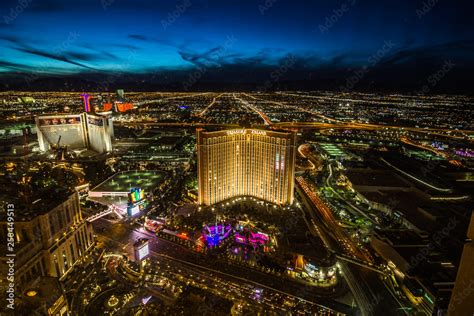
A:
<box><xmin>36</xmin><ymin>113</ymin><xmax>113</xmax><ymax>153</ymax></box>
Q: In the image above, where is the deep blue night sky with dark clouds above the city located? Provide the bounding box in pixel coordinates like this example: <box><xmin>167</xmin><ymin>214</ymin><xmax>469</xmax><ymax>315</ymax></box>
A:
<box><xmin>0</xmin><ymin>0</ymin><xmax>474</xmax><ymax>93</ymax></box>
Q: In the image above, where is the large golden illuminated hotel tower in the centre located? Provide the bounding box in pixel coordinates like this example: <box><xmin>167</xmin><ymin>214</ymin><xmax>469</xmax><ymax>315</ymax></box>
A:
<box><xmin>197</xmin><ymin>129</ymin><xmax>296</xmax><ymax>205</ymax></box>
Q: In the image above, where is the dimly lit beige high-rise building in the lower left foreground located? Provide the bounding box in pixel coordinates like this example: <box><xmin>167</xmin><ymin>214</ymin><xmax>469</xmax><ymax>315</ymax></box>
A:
<box><xmin>0</xmin><ymin>192</ymin><xmax>94</xmax><ymax>292</ymax></box>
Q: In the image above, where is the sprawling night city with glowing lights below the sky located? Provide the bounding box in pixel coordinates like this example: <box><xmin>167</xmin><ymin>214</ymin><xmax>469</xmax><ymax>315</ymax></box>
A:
<box><xmin>0</xmin><ymin>89</ymin><xmax>474</xmax><ymax>315</ymax></box>
